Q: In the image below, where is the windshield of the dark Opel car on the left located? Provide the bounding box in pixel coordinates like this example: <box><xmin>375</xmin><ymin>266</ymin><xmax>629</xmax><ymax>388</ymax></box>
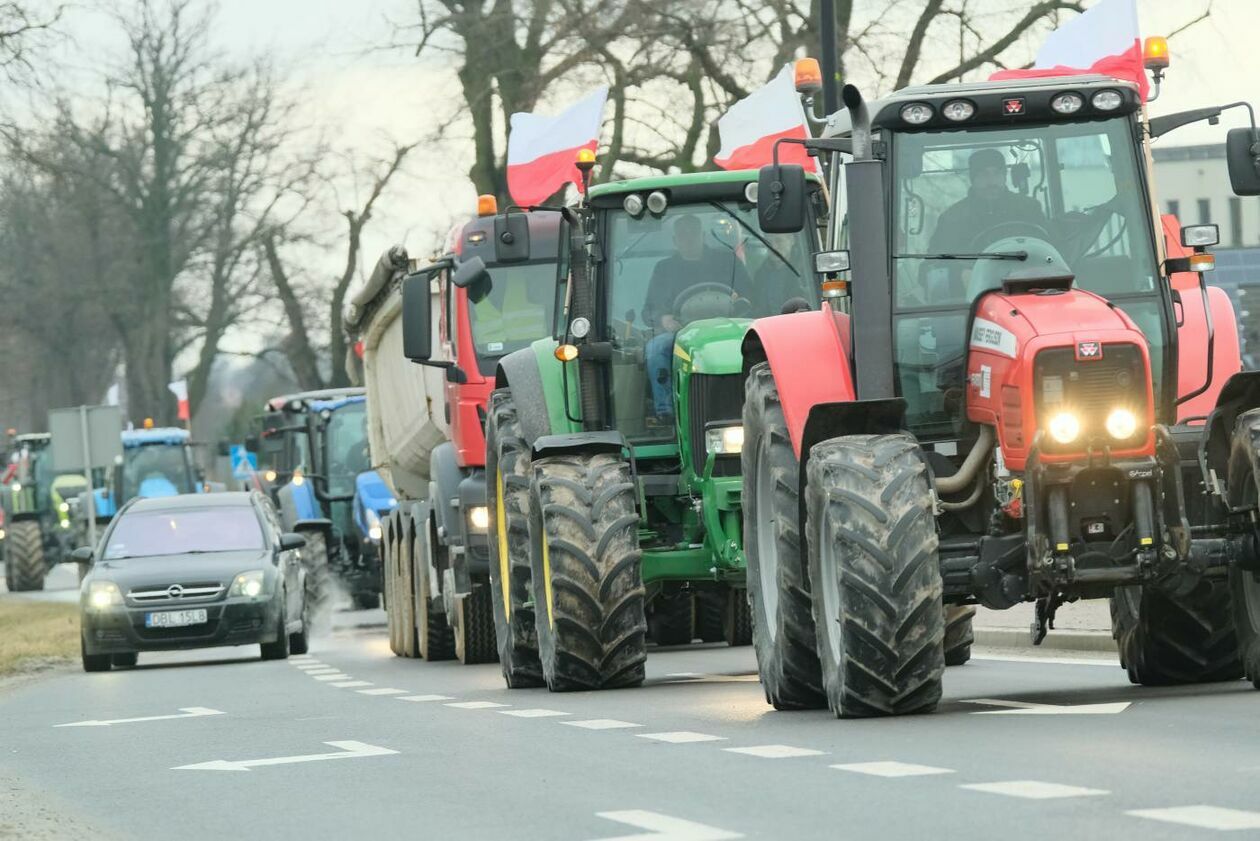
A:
<box><xmin>105</xmin><ymin>506</ymin><xmax>263</xmax><ymax>561</ymax></box>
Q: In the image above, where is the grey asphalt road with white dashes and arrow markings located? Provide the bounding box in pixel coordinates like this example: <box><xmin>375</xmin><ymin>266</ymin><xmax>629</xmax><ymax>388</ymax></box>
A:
<box><xmin>0</xmin><ymin>590</ymin><xmax>1260</xmax><ymax>841</ymax></box>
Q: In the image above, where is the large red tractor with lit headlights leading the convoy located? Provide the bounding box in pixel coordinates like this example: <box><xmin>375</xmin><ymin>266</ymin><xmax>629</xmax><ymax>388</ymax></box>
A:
<box><xmin>742</xmin><ymin>76</ymin><xmax>1260</xmax><ymax>717</ymax></box>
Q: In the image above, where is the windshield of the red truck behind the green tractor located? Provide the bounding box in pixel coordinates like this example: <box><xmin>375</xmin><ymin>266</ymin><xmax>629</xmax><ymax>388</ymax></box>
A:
<box><xmin>467</xmin><ymin>261</ymin><xmax>556</xmax><ymax>373</ymax></box>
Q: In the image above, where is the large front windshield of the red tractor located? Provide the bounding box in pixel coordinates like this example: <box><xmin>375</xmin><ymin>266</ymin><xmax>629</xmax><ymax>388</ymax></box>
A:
<box><xmin>893</xmin><ymin>119</ymin><xmax>1166</xmax><ymax>438</ymax></box>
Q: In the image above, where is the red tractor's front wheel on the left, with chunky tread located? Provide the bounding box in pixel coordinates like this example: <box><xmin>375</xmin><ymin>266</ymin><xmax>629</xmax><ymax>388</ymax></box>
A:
<box><xmin>805</xmin><ymin>435</ymin><xmax>945</xmax><ymax>717</ymax></box>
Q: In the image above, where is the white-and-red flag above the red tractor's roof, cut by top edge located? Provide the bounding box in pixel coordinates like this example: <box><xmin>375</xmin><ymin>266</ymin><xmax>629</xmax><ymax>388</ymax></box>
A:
<box><xmin>989</xmin><ymin>0</ymin><xmax>1150</xmax><ymax>102</ymax></box>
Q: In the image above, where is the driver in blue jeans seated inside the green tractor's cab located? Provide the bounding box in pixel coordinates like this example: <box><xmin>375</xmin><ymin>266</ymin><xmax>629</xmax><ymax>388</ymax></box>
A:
<box><xmin>643</xmin><ymin>213</ymin><xmax>750</xmax><ymax>422</ymax></box>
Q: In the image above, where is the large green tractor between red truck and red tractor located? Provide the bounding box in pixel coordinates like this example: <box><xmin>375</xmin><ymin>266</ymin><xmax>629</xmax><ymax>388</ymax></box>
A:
<box><xmin>486</xmin><ymin>164</ymin><xmax>825</xmax><ymax>691</ymax></box>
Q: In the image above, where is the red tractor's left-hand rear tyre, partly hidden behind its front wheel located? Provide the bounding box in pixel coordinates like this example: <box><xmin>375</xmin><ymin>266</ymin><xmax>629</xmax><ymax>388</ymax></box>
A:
<box><xmin>742</xmin><ymin>362</ymin><xmax>827</xmax><ymax>710</ymax></box>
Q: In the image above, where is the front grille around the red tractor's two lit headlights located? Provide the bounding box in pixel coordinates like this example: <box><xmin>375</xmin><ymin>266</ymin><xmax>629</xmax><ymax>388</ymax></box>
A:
<box><xmin>1033</xmin><ymin>344</ymin><xmax>1149</xmax><ymax>453</ymax></box>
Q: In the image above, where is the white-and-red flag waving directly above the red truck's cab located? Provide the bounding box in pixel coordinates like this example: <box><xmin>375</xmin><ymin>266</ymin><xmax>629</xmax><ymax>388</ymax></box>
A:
<box><xmin>508</xmin><ymin>87</ymin><xmax>609</xmax><ymax>207</ymax></box>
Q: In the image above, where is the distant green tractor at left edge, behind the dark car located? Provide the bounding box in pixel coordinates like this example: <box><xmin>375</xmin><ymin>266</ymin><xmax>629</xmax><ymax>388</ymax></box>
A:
<box><xmin>0</xmin><ymin>432</ymin><xmax>87</xmax><ymax>591</ymax></box>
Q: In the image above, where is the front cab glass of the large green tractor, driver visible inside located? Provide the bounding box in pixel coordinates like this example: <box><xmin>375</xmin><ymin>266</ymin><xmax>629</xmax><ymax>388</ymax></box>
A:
<box><xmin>604</xmin><ymin>200</ymin><xmax>818</xmax><ymax>440</ymax></box>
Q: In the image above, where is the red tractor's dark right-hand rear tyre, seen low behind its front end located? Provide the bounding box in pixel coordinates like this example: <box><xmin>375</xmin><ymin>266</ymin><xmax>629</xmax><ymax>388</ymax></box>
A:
<box><xmin>1111</xmin><ymin>581</ymin><xmax>1242</xmax><ymax>686</ymax></box>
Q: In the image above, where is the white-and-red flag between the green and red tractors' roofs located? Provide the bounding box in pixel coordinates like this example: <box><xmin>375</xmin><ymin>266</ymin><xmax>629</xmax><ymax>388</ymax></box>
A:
<box><xmin>713</xmin><ymin>64</ymin><xmax>816</xmax><ymax>169</ymax></box>
